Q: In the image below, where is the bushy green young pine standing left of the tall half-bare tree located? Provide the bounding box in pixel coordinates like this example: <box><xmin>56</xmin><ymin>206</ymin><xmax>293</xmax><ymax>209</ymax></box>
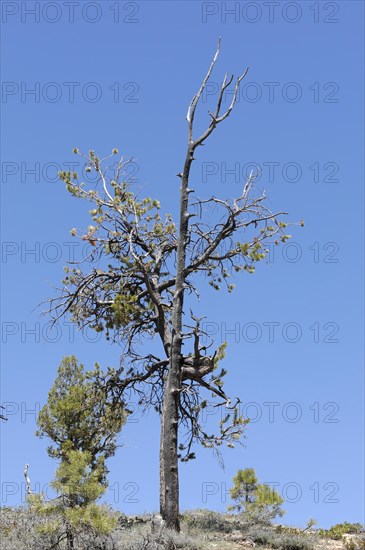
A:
<box><xmin>28</xmin><ymin>356</ymin><xmax>127</xmax><ymax>550</ymax></box>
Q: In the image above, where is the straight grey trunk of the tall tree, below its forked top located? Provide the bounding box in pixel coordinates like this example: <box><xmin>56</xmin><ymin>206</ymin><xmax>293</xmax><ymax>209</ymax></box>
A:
<box><xmin>160</xmin><ymin>149</ymin><xmax>194</xmax><ymax>531</ymax></box>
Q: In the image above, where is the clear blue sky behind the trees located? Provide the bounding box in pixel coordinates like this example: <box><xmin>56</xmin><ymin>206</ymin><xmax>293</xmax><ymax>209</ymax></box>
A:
<box><xmin>1</xmin><ymin>1</ymin><xmax>364</xmax><ymax>527</ymax></box>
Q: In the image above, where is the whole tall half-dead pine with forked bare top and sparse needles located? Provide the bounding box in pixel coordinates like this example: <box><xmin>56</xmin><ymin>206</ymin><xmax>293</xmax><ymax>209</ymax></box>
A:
<box><xmin>49</xmin><ymin>37</ymin><xmax>303</xmax><ymax>531</ymax></box>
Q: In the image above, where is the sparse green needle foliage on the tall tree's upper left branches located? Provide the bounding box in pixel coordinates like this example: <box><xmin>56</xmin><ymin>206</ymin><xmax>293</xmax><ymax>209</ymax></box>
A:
<box><xmin>59</xmin><ymin>153</ymin><xmax>176</xmax><ymax>339</ymax></box>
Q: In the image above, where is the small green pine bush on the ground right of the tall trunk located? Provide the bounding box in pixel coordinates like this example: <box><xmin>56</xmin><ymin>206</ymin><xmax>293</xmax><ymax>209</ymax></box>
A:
<box><xmin>228</xmin><ymin>468</ymin><xmax>284</xmax><ymax>524</ymax></box>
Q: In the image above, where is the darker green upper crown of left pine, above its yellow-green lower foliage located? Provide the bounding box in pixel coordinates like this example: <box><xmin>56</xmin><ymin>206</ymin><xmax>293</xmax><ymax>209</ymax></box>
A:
<box><xmin>36</xmin><ymin>356</ymin><xmax>126</xmax><ymax>483</ymax></box>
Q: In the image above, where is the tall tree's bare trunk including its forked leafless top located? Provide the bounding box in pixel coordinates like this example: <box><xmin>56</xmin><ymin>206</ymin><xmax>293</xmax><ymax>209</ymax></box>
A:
<box><xmin>160</xmin><ymin>38</ymin><xmax>248</xmax><ymax>531</ymax></box>
